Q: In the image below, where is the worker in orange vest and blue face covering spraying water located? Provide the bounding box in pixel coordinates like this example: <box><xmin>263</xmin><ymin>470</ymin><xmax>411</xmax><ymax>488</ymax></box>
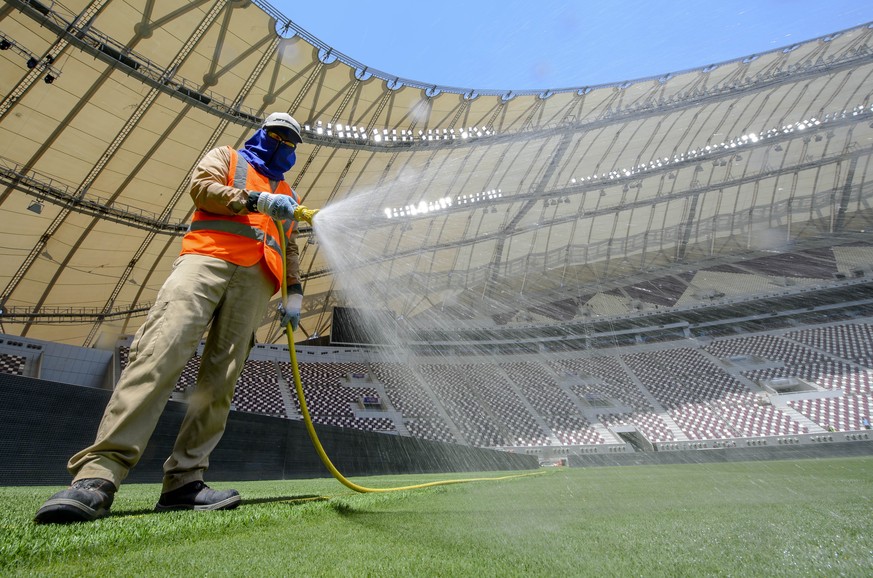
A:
<box><xmin>35</xmin><ymin>113</ymin><xmax>318</xmax><ymax>523</ymax></box>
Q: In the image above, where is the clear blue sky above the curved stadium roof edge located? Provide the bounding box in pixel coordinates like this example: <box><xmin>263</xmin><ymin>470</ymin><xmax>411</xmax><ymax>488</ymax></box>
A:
<box><xmin>269</xmin><ymin>0</ymin><xmax>873</xmax><ymax>90</ymax></box>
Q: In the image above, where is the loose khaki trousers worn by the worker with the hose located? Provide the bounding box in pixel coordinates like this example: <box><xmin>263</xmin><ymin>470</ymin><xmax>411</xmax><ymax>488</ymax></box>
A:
<box><xmin>67</xmin><ymin>255</ymin><xmax>275</xmax><ymax>492</ymax></box>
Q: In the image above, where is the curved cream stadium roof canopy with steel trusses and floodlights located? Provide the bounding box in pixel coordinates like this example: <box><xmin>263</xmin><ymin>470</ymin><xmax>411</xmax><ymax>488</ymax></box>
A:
<box><xmin>0</xmin><ymin>0</ymin><xmax>873</xmax><ymax>345</ymax></box>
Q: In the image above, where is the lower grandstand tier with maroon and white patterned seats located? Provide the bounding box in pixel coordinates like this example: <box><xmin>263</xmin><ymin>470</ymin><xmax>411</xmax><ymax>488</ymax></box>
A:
<box><xmin>0</xmin><ymin>319</ymin><xmax>873</xmax><ymax>456</ymax></box>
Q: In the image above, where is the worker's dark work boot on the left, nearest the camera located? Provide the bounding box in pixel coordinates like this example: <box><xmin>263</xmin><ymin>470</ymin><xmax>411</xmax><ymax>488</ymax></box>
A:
<box><xmin>34</xmin><ymin>478</ymin><xmax>116</xmax><ymax>524</ymax></box>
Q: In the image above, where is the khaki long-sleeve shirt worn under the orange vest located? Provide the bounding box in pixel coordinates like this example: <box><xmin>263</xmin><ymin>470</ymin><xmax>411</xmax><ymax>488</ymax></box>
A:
<box><xmin>191</xmin><ymin>147</ymin><xmax>300</xmax><ymax>287</ymax></box>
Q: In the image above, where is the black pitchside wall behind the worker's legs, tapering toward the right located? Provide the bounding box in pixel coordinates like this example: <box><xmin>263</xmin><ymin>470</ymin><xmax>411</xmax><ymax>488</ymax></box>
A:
<box><xmin>0</xmin><ymin>374</ymin><xmax>539</xmax><ymax>486</ymax></box>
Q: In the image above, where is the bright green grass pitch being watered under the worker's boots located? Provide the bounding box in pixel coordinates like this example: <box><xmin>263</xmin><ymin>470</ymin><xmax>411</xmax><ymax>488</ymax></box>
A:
<box><xmin>0</xmin><ymin>457</ymin><xmax>873</xmax><ymax>577</ymax></box>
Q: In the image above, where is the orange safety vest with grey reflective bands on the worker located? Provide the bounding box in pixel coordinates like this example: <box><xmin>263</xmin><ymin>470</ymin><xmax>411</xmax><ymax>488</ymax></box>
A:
<box><xmin>180</xmin><ymin>147</ymin><xmax>300</xmax><ymax>290</ymax></box>
